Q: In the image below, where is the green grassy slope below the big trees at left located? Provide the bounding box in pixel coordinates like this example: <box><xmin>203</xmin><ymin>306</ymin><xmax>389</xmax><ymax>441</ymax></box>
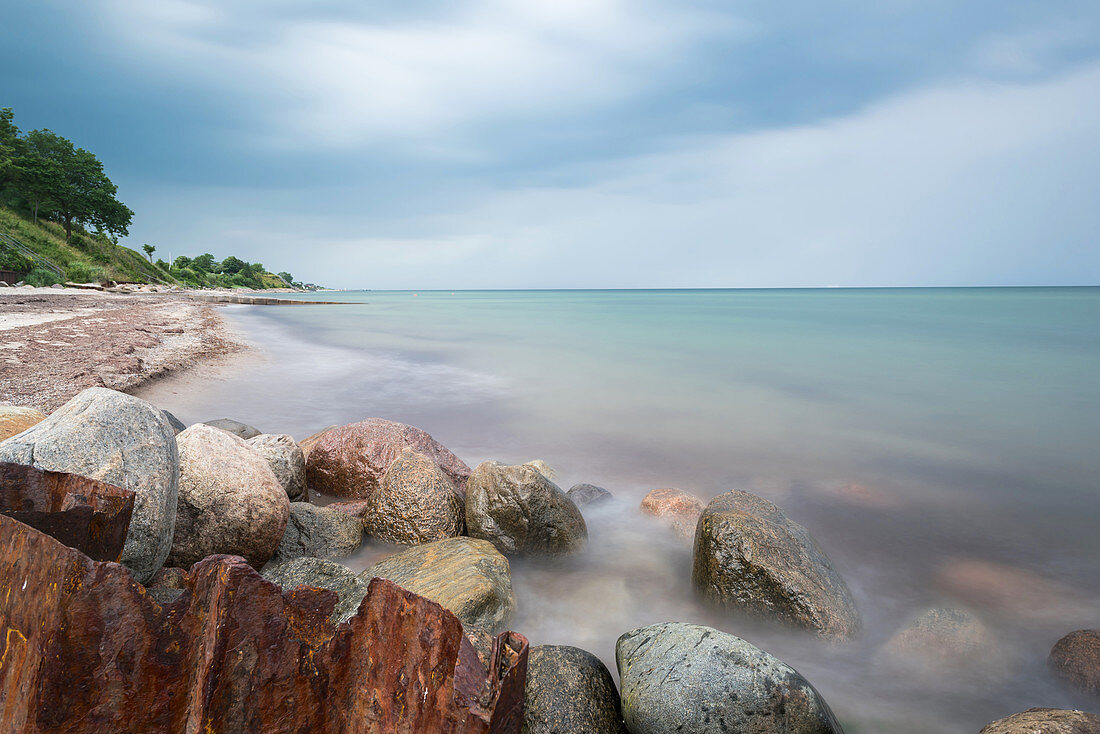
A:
<box><xmin>0</xmin><ymin>207</ymin><xmax>176</xmax><ymax>283</ymax></box>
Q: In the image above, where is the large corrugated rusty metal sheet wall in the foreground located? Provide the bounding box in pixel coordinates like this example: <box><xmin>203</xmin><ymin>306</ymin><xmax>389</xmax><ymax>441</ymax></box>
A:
<box><xmin>0</xmin><ymin>516</ymin><xmax>527</xmax><ymax>734</ymax></box>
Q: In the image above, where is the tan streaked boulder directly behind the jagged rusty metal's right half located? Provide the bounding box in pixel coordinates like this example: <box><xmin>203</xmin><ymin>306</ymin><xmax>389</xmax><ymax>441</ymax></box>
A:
<box><xmin>360</xmin><ymin>537</ymin><xmax>516</xmax><ymax>633</ymax></box>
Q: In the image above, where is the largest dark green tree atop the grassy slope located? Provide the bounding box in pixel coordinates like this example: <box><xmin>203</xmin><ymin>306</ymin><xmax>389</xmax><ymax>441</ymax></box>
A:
<box><xmin>13</xmin><ymin>130</ymin><xmax>133</xmax><ymax>241</ymax></box>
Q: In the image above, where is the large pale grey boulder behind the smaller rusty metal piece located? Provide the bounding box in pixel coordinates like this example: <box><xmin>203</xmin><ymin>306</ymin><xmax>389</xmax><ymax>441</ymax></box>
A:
<box><xmin>0</xmin><ymin>387</ymin><xmax>179</xmax><ymax>582</ymax></box>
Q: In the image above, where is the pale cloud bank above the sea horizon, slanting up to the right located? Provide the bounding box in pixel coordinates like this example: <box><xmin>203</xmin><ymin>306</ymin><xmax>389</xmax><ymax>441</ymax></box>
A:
<box><xmin>141</xmin><ymin>65</ymin><xmax>1100</xmax><ymax>288</ymax></box>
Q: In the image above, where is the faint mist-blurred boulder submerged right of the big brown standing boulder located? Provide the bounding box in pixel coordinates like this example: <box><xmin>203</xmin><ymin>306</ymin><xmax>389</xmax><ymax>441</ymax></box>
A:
<box><xmin>875</xmin><ymin>609</ymin><xmax>1004</xmax><ymax>684</ymax></box>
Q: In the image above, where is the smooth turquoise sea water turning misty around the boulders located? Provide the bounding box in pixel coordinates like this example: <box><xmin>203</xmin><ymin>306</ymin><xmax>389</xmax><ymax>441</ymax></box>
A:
<box><xmin>137</xmin><ymin>288</ymin><xmax>1100</xmax><ymax>732</ymax></box>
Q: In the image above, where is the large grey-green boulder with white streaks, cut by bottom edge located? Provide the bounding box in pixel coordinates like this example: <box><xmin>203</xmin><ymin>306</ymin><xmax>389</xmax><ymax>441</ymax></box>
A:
<box><xmin>615</xmin><ymin>622</ymin><xmax>843</xmax><ymax>734</ymax></box>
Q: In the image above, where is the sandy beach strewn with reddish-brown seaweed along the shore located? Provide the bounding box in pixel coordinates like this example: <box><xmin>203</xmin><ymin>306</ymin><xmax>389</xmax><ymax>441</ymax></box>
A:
<box><xmin>0</xmin><ymin>288</ymin><xmax>246</xmax><ymax>413</ymax></box>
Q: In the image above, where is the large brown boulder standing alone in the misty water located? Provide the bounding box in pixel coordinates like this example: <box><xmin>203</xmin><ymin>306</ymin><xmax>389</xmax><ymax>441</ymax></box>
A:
<box><xmin>692</xmin><ymin>490</ymin><xmax>860</xmax><ymax>637</ymax></box>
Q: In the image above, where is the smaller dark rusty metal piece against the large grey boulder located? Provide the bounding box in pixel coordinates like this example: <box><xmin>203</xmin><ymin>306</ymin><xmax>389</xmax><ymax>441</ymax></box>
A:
<box><xmin>0</xmin><ymin>462</ymin><xmax>134</xmax><ymax>561</ymax></box>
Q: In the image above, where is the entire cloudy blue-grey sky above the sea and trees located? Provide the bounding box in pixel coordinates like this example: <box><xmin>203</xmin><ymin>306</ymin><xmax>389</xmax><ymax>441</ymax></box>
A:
<box><xmin>0</xmin><ymin>0</ymin><xmax>1100</xmax><ymax>288</ymax></box>
